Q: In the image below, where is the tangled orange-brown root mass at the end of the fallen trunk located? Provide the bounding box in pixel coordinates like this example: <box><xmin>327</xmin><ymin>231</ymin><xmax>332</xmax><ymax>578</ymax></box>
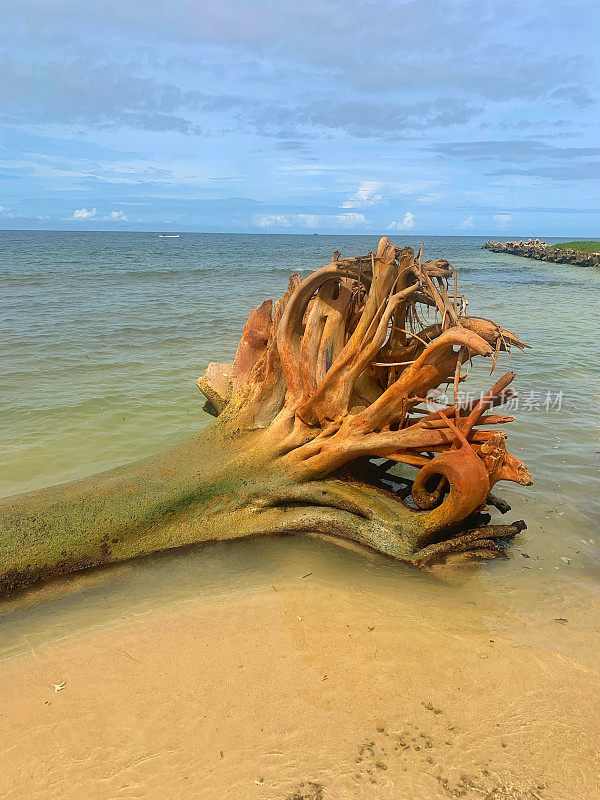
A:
<box><xmin>199</xmin><ymin>237</ymin><xmax>531</xmax><ymax>565</ymax></box>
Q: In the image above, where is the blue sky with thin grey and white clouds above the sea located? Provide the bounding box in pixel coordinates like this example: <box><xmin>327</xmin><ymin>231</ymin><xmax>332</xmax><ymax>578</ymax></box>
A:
<box><xmin>0</xmin><ymin>0</ymin><xmax>600</xmax><ymax>234</ymax></box>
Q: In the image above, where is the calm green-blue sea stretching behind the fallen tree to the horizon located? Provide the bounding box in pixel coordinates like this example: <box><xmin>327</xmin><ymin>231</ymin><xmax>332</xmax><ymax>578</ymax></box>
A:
<box><xmin>0</xmin><ymin>232</ymin><xmax>600</xmax><ymax>577</ymax></box>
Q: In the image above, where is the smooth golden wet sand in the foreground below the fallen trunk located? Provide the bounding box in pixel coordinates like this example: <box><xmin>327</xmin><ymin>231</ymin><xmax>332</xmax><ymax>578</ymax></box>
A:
<box><xmin>0</xmin><ymin>537</ymin><xmax>600</xmax><ymax>800</ymax></box>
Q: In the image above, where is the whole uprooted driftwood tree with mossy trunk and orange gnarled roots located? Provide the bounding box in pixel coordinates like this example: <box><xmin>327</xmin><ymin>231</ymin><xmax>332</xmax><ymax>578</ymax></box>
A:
<box><xmin>0</xmin><ymin>237</ymin><xmax>531</xmax><ymax>591</ymax></box>
